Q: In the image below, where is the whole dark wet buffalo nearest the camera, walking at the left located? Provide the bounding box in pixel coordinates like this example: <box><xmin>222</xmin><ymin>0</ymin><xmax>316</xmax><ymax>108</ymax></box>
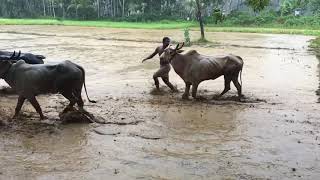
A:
<box><xmin>0</xmin><ymin>60</ymin><xmax>95</xmax><ymax>119</ymax></box>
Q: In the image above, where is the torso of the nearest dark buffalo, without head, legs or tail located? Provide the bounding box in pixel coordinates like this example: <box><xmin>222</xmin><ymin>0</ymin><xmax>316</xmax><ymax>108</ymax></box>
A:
<box><xmin>12</xmin><ymin>61</ymin><xmax>82</xmax><ymax>94</ymax></box>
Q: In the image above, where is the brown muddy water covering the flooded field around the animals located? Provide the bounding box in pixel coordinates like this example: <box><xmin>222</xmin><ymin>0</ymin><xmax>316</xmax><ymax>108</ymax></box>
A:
<box><xmin>0</xmin><ymin>26</ymin><xmax>320</xmax><ymax>179</ymax></box>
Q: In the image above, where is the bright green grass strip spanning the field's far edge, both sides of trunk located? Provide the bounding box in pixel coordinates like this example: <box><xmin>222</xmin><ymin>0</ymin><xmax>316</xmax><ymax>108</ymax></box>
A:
<box><xmin>0</xmin><ymin>19</ymin><xmax>320</xmax><ymax>36</ymax></box>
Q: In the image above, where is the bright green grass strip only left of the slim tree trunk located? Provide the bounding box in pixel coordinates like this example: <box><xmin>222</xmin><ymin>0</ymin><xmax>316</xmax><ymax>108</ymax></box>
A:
<box><xmin>0</xmin><ymin>19</ymin><xmax>196</xmax><ymax>29</ymax></box>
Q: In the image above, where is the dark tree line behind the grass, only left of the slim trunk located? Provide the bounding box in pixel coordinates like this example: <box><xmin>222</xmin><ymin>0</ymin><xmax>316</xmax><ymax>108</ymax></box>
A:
<box><xmin>0</xmin><ymin>0</ymin><xmax>201</xmax><ymax>22</ymax></box>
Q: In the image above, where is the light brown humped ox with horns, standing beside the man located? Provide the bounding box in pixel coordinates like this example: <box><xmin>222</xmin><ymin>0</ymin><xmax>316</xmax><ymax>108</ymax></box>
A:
<box><xmin>160</xmin><ymin>43</ymin><xmax>243</xmax><ymax>100</ymax></box>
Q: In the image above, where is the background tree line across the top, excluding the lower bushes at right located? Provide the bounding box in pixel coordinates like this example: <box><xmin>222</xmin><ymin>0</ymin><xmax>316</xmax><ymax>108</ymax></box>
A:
<box><xmin>0</xmin><ymin>0</ymin><xmax>320</xmax><ymax>21</ymax></box>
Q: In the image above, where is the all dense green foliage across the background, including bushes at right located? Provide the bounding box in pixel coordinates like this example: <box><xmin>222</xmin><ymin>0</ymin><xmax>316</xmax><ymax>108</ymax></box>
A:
<box><xmin>0</xmin><ymin>0</ymin><xmax>320</xmax><ymax>27</ymax></box>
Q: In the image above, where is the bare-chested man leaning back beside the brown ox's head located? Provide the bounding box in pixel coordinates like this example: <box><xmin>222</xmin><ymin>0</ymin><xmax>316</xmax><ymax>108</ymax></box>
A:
<box><xmin>142</xmin><ymin>37</ymin><xmax>178</xmax><ymax>92</ymax></box>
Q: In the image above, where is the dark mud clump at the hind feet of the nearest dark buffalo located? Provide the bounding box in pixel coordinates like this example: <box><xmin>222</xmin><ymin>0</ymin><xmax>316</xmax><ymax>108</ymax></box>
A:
<box><xmin>59</xmin><ymin>108</ymin><xmax>95</xmax><ymax>123</ymax></box>
